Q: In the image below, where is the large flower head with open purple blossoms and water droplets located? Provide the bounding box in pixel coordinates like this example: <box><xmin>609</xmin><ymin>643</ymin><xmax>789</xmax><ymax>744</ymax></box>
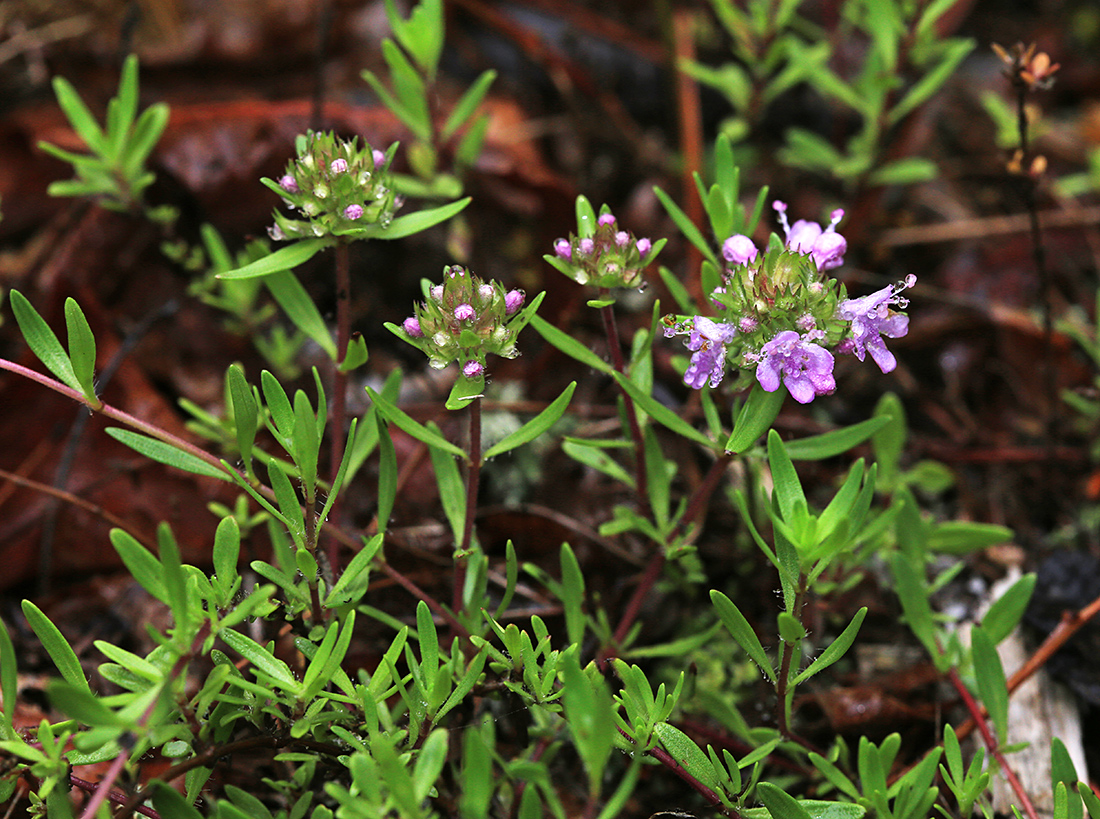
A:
<box><xmin>663</xmin><ymin>201</ymin><xmax>916</xmax><ymax>403</ymax></box>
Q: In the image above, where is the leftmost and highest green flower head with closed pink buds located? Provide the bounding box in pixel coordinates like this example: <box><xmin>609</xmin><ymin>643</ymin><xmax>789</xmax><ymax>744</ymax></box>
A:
<box><xmin>263</xmin><ymin>131</ymin><xmax>397</xmax><ymax>241</ymax></box>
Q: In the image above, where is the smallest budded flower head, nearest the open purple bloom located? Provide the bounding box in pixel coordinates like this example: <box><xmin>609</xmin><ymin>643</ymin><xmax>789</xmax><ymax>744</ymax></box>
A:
<box><xmin>546</xmin><ymin>207</ymin><xmax>666</xmax><ymax>289</ymax></box>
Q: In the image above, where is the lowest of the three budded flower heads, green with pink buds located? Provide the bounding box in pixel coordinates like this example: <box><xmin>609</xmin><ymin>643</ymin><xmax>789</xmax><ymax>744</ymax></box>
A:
<box><xmin>387</xmin><ymin>265</ymin><xmax>526</xmax><ymax>379</ymax></box>
